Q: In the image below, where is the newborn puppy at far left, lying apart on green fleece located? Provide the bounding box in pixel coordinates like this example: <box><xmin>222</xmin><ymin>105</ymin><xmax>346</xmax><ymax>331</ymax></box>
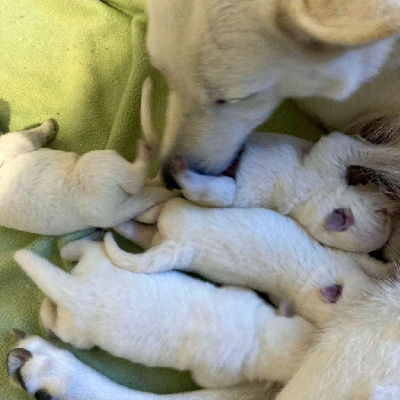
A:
<box><xmin>0</xmin><ymin>120</ymin><xmax>172</xmax><ymax>235</ymax></box>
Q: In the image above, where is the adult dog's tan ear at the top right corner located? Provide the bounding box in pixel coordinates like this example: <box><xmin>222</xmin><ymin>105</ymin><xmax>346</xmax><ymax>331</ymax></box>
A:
<box><xmin>276</xmin><ymin>0</ymin><xmax>400</xmax><ymax>46</ymax></box>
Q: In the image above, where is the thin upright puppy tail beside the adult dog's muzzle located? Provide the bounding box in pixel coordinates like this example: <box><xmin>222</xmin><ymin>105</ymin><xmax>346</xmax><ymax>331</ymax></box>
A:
<box><xmin>140</xmin><ymin>77</ymin><xmax>161</xmax><ymax>155</ymax></box>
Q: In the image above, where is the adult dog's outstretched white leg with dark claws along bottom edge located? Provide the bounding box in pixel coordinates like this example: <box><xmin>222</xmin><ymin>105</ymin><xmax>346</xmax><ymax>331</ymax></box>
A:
<box><xmin>7</xmin><ymin>332</ymin><xmax>279</xmax><ymax>400</ymax></box>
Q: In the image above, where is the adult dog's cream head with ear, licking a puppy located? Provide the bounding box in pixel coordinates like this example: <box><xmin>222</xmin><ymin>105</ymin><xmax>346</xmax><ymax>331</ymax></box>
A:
<box><xmin>147</xmin><ymin>0</ymin><xmax>400</xmax><ymax>182</ymax></box>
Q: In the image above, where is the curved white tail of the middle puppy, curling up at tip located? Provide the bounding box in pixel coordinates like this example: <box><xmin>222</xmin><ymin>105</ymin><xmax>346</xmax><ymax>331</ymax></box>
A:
<box><xmin>104</xmin><ymin>232</ymin><xmax>194</xmax><ymax>273</ymax></box>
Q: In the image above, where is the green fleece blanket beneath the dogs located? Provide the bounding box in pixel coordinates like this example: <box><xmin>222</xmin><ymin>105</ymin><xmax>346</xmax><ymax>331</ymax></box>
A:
<box><xmin>0</xmin><ymin>0</ymin><xmax>319</xmax><ymax>400</ymax></box>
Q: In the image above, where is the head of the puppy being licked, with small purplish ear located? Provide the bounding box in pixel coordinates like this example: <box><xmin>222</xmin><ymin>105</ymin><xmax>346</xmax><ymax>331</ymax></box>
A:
<box><xmin>294</xmin><ymin>185</ymin><xmax>392</xmax><ymax>253</ymax></box>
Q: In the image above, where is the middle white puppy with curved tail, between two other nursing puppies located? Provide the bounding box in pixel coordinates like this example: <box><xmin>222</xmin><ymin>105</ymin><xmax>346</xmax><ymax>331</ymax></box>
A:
<box><xmin>105</xmin><ymin>199</ymin><xmax>392</xmax><ymax>326</ymax></box>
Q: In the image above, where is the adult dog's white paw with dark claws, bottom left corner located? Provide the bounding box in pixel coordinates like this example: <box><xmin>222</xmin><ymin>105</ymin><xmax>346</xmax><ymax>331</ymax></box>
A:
<box><xmin>7</xmin><ymin>336</ymin><xmax>76</xmax><ymax>400</ymax></box>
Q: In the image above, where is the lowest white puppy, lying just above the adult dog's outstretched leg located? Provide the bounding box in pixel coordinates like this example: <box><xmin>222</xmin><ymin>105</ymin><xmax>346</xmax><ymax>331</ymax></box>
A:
<box><xmin>11</xmin><ymin>239</ymin><xmax>317</xmax><ymax>387</ymax></box>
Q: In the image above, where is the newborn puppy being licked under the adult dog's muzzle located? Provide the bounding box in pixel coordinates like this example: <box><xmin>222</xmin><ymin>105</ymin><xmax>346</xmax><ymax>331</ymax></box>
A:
<box><xmin>175</xmin><ymin>132</ymin><xmax>391</xmax><ymax>253</ymax></box>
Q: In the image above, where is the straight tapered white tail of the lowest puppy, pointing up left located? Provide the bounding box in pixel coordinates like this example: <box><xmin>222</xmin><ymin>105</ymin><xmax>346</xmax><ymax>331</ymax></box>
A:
<box><xmin>14</xmin><ymin>249</ymin><xmax>81</xmax><ymax>310</ymax></box>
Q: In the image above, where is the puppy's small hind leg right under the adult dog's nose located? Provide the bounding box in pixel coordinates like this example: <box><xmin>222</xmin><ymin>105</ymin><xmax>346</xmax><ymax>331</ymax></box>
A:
<box><xmin>174</xmin><ymin>161</ymin><xmax>236</xmax><ymax>207</ymax></box>
